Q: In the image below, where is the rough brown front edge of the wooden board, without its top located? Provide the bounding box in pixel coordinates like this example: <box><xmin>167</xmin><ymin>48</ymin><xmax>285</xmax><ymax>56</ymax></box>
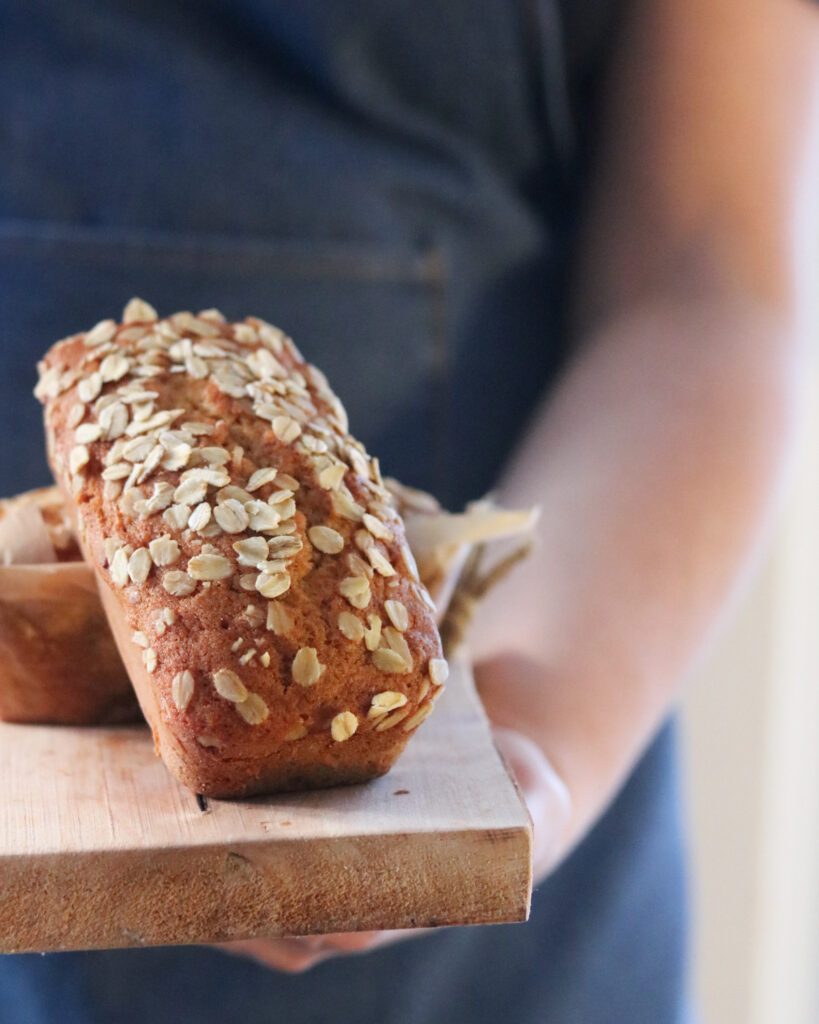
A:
<box><xmin>0</xmin><ymin>827</ymin><xmax>531</xmax><ymax>953</ymax></box>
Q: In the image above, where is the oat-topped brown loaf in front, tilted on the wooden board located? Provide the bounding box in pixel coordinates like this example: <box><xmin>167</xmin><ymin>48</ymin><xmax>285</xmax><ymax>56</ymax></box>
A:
<box><xmin>36</xmin><ymin>299</ymin><xmax>447</xmax><ymax>797</ymax></box>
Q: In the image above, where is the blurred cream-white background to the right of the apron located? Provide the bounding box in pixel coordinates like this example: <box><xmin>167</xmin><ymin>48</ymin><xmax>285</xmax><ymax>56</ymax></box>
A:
<box><xmin>683</xmin><ymin>364</ymin><xmax>819</xmax><ymax>1024</ymax></box>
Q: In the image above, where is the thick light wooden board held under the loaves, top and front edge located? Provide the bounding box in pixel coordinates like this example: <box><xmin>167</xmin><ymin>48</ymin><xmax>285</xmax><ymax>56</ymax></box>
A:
<box><xmin>0</xmin><ymin>666</ymin><xmax>531</xmax><ymax>952</ymax></box>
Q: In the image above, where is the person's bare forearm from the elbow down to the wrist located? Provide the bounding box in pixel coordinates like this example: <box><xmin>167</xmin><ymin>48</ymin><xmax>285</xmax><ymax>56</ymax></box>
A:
<box><xmin>474</xmin><ymin>300</ymin><xmax>800</xmax><ymax>856</ymax></box>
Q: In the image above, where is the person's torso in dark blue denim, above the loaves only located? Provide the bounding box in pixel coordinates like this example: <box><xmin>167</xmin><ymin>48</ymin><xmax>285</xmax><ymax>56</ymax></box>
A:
<box><xmin>0</xmin><ymin>0</ymin><xmax>618</xmax><ymax>504</ymax></box>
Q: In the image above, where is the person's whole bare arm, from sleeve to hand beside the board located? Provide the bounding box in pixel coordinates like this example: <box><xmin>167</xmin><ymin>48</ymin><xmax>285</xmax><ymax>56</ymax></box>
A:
<box><xmin>474</xmin><ymin>0</ymin><xmax>819</xmax><ymax>856</ymax></box>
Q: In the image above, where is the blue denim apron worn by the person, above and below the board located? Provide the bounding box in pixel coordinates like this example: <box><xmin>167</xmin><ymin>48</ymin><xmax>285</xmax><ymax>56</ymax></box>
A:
<box><xmin>0</xmin><ymin>0</ymin><xmax>686</xmax><ymax>1024</ymax></box>
